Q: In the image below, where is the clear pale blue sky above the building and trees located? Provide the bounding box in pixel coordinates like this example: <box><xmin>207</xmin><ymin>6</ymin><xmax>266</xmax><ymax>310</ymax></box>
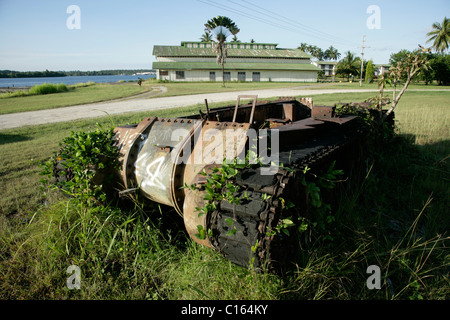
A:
<box><xmin>0</xmin><ymin>0</ymin><xmax>450</xmax><ymax>71</ymax></box>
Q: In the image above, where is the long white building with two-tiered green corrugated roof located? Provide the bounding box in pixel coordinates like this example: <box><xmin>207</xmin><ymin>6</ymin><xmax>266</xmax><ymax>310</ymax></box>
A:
<box><xmin>153</xmin><ymin>42</ymin><xmax>320</xmax><ymax>82</ymax></box>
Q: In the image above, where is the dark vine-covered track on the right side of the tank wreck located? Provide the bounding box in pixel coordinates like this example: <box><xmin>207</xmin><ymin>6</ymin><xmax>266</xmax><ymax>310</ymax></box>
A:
<box><xmin>208</xmin><ymin>120</ymin><xmax>363</xmax><ymax>271</ymax></box>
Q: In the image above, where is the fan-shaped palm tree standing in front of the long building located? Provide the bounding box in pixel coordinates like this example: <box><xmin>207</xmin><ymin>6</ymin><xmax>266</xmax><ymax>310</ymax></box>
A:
<box><xmin>205</xmin><ymin>16</ymin><xmax>239</xmax><ymax>86</ymax></box>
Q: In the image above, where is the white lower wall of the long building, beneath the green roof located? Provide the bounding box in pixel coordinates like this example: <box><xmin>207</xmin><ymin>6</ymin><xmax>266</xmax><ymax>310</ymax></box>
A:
<box><xmin>157</xmin><ymin>70</ymin><xmax>317</xmax><ymax>82</ymax></box>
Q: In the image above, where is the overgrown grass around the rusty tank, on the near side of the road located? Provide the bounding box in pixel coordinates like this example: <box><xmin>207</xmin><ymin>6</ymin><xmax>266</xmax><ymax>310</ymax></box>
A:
<box><xmin>0</xmin><ymin>86</ymin><xmax>450</xmax><ymax>299</ymax></box>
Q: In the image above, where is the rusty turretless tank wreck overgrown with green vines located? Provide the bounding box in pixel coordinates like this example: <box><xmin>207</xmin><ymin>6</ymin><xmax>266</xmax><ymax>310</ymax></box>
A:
<box><xmin>106</xmin><ymin>96</ymin><xmax>386</xmax><ymax>267</ymax></box>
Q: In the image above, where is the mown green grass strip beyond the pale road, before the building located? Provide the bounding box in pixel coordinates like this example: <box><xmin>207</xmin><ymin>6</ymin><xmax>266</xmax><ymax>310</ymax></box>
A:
<box><xmin>0</xmin><ymin>80</ymin><xmax>448</xmax><ymax>115</ymax></box>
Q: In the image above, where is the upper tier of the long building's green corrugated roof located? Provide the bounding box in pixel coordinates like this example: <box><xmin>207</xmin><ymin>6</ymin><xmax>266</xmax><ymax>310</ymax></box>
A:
<box><xmin>153</xmin><ymin>46</ymin><xmax>311</xmax><ymax>59</ymax></box>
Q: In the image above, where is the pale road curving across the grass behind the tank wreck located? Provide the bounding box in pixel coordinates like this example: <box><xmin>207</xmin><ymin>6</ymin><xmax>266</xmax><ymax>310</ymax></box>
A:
<box><xmin>0</xmin><ymin>87</ymin><xmax>446</xmax><ymax>129</ymax></box>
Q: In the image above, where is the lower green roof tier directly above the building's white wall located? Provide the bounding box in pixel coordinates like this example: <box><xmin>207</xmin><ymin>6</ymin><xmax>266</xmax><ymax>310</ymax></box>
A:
<box><xmin>152</xmin><ymin>62</ymin><xmax>320</xmax><ymax>71</ymax></box>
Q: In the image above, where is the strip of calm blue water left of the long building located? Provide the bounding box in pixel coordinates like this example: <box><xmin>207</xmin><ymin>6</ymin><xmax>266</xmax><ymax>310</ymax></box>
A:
<box><xmin>0</xmin><ymin>75</ymin><xmax>155</xmax><ymax>87</ymax></box>
